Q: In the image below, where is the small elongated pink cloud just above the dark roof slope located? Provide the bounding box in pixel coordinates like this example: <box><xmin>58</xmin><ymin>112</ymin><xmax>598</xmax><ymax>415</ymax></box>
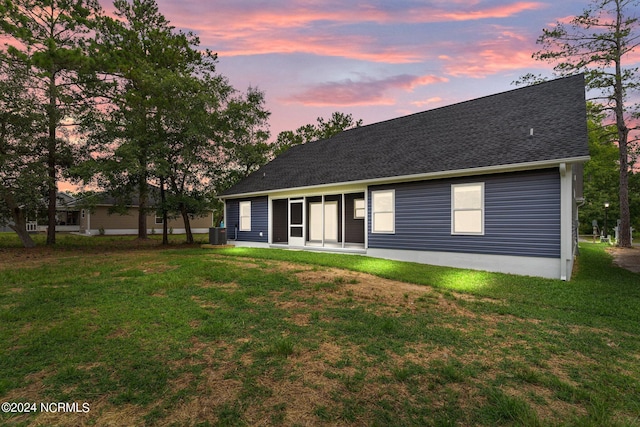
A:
<box><xmin>284</xmin><ymin>75</ymin><xmax>448</xmax><ymax>106</ymax></box>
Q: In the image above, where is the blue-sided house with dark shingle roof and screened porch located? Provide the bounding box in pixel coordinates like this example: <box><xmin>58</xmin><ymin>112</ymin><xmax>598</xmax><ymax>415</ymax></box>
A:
<box><xmin>221</xmin><ymin>75</ymin><xmax>589</xmax><ymax>280</ymax></box>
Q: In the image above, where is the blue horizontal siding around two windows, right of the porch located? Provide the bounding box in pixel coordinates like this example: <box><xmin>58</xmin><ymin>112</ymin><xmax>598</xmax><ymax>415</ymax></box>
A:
<box><xmin>368</xmin><ymin>169</ymin><xmax>560</xmax><ymax>258</ymax></box>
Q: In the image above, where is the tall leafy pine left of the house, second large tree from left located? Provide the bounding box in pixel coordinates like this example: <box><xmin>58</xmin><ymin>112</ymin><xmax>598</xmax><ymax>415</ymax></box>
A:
<box><xmin>87</xmin><ymin>0</ymin><xmax>206</xmax><ymax>239</ymax></box>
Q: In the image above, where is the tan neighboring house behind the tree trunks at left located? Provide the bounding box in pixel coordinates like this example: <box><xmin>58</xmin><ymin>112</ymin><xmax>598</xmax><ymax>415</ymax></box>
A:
<box><xmin>76</xmin><ymin>193</ymin><xmax>213</xmax><ymax>235</ymax></box>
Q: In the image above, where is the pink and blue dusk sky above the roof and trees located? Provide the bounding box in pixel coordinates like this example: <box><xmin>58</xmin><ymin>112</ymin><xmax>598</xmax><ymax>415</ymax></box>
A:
<box><xmin>126</xmin><ymin>0</ymin><xmax>632</xmax><ymax>140</ymax></box>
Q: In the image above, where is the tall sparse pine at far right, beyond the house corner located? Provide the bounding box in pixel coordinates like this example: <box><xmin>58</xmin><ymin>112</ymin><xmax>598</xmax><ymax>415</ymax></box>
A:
<box><xmin>533</xmin><ymin>0</ymin><xmax>640</xmax><ymax>247</ymax></box>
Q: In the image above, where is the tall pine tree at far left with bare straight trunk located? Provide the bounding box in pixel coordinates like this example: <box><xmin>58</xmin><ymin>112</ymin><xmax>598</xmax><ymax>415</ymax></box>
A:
<box><xmin>0</xmin><ymin>0</ymin><xmax>101</xmax><ymax>245</ymax></box>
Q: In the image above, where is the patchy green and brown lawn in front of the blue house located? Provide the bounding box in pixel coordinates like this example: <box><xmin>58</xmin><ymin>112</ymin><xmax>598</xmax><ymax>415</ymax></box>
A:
<box><xmin>0</xmin><ymin>234</ymin><xmax>640</xmax><ymax>426</ymax></box>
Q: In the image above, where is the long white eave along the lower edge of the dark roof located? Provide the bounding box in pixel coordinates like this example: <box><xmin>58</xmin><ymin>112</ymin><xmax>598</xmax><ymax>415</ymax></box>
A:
<box><xmin>218</xmin><ymin>156</ymin><xmax>590</xmax><ymax>200</ymax></box>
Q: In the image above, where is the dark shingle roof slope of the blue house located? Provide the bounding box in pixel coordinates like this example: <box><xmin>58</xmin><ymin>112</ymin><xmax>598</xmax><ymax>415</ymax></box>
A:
<box><xmin>223</xmin><ymin>75</ymin><xmax>589</xmax><ymax>196</ymax></box>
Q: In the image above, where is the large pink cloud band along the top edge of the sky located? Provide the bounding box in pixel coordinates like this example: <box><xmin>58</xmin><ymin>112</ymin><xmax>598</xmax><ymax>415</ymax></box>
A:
<box><xmin>164</xmin><ymin>0</ymin><xmax>544</xmax><ymax>64</ymax></box>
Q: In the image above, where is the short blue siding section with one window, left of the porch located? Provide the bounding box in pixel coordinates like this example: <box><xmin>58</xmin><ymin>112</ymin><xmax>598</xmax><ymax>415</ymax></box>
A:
<box><xmin>227</xmin><ymin>197</ymin><xmax>269</xmax><ymax>243</ymax></box>
